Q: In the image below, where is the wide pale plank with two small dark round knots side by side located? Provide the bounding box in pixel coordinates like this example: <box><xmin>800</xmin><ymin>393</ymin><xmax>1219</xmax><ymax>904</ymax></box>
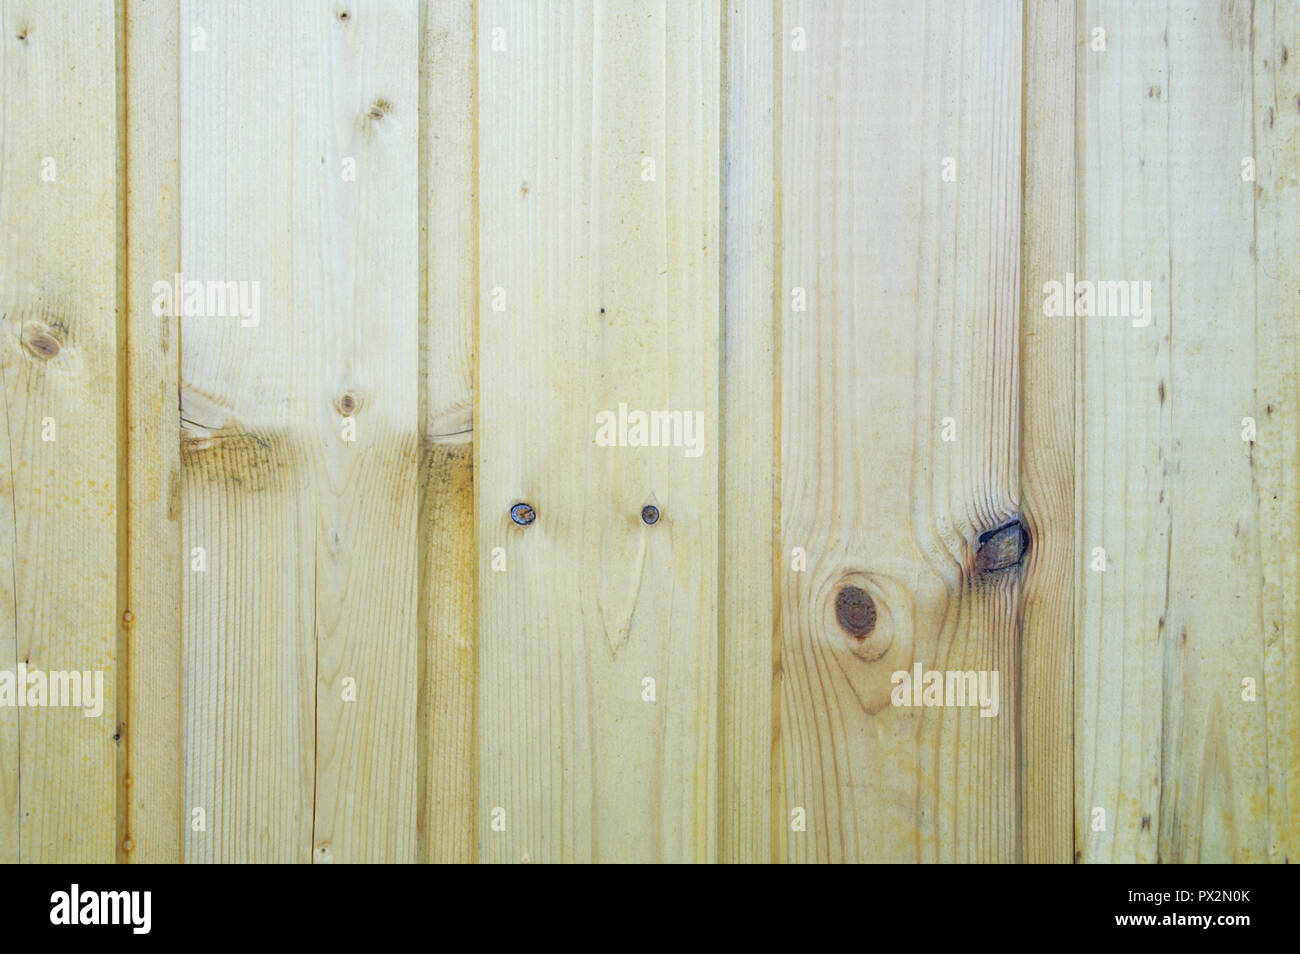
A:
<box><xmin>475</xmin><ymin>0</ymin><xmax>722</xmax><ymax>862</ymax></box>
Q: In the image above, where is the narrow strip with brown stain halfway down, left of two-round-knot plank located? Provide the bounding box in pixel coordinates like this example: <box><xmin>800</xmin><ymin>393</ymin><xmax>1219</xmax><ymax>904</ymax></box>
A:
<box><xmin>417</xmin><ymin>0</ymin><xmax>478</xmax><ymax>862</ymax></box>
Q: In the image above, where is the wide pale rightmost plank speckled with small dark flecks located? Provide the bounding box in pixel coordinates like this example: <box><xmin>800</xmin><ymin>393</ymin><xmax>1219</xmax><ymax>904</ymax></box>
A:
<box><xmin>1076</xmin><ymin>0</ymin><xmax>1296</xmax><ymax>862</ymax></box>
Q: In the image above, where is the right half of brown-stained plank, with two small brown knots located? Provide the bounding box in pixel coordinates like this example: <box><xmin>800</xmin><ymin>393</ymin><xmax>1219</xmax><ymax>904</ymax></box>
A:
<box><xmin>294</xmin><ymin>0</ymin><xmax>421</xmax><ymax>863</ymax></box>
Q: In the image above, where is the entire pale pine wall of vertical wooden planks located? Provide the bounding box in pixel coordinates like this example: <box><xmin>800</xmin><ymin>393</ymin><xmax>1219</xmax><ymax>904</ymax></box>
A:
<box><xmin>0</xmin><ymin>0</ymin><xmax>1300</xmax><ymax>863</ymax></box>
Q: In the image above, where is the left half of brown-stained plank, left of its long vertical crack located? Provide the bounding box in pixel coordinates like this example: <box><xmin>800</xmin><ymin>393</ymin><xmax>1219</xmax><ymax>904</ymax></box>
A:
<box><xmin>179</xmin><ymin>0</ymin><xmax>319</xmax><ymax>862</ymax></box>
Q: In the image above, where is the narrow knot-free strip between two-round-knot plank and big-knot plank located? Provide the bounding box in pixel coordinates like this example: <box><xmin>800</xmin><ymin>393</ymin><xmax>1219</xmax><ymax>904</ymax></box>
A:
<box><xmin>718</xmin><ymin>3</ymin><xmax>774</xmax><ymax>863</ymax></box>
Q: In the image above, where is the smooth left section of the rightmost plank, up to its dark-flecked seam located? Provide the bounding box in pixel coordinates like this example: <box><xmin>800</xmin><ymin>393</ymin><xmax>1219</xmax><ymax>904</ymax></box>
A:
<box><xmin>1076</xmin><ymin>1</ymin><xmax>1178</xmax><ymax>862</ymax></box>
